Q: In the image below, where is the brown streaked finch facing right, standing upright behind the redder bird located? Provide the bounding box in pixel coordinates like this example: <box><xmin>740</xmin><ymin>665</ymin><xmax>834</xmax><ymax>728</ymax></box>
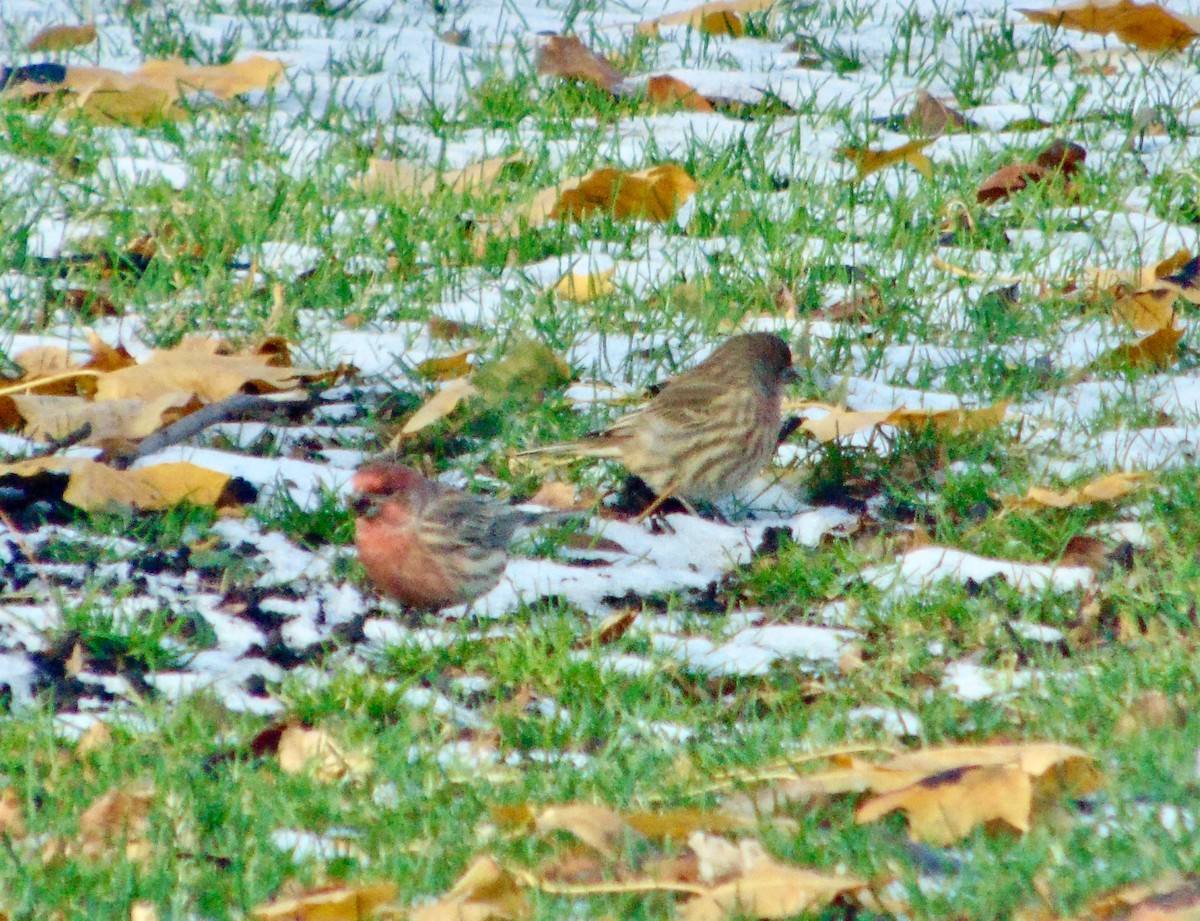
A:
<box><xmin>520</xmin><ymin>332</ymin><xmax>796</xmax><ymax>508</ymax></box>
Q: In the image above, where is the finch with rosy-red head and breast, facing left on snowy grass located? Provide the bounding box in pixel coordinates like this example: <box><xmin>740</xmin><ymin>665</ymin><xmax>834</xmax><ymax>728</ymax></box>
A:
<box><xmin>350</xmin><ymin>461</ymin><xmax>552</xmax><ymax>610</ymax></box>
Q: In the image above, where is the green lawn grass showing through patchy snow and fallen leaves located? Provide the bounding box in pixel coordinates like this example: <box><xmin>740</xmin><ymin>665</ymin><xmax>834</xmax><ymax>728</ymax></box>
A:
<box><xmin>7</xmin><ymin>0</ymin><xmax>1200</xmax><ymax>920</ymax></box>
